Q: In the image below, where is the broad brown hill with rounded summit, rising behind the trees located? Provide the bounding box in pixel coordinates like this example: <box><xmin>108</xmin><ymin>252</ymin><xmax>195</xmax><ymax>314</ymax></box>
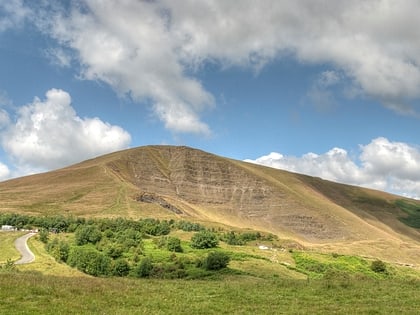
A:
<box><xmin>0</xmin><ymin>146</ymin><xmax>420</xmax><ymax>263</ymax></box>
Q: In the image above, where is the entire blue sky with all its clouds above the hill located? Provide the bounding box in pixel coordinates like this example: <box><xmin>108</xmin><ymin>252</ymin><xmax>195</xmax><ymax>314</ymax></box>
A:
<box><xmin>0</xmin><ymin>0</ymin><xmax>420</xmax><ymax>198</ymax></box>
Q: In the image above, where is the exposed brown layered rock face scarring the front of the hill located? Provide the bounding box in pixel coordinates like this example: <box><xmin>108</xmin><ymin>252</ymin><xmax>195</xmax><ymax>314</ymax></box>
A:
<box><xmin>106</xmin><ymin>146</ymin><xmax>348</xmax><ymax>239</ymax></box>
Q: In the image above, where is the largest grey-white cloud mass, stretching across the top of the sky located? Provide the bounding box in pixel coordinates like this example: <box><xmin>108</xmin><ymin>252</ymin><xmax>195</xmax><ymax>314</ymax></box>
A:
<box><xmin>24</xmin><ymin>0</ymin><xmax>420</xmax><ymax>133</ymax></box>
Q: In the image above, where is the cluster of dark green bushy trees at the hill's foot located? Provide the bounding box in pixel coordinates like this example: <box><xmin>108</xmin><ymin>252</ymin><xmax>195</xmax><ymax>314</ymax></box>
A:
<box><xmin>0</xmin><ymin>214</ymin><xmax>272</xmax><ymax>278</ymax></box>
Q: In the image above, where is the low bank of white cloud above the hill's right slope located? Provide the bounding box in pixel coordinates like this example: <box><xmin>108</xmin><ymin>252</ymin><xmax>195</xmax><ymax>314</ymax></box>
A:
<box><xmin>246</xmin><ymin>137</ymin><xmax>420</xmax><ymax>198</ymax></box>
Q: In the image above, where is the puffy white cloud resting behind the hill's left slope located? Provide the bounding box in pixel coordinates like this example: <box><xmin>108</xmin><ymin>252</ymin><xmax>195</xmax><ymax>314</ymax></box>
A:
<box><xmin>1</xmin><ymin>89</ymin><xmax>131</xmax><ymax>173</ymax></box>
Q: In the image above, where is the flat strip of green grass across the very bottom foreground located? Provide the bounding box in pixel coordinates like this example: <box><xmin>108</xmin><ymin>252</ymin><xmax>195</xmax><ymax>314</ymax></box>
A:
<box><xmin>0</xmin><ymin>272</ymin><xmax>420</xmax><ymax>314</ymax></box>
